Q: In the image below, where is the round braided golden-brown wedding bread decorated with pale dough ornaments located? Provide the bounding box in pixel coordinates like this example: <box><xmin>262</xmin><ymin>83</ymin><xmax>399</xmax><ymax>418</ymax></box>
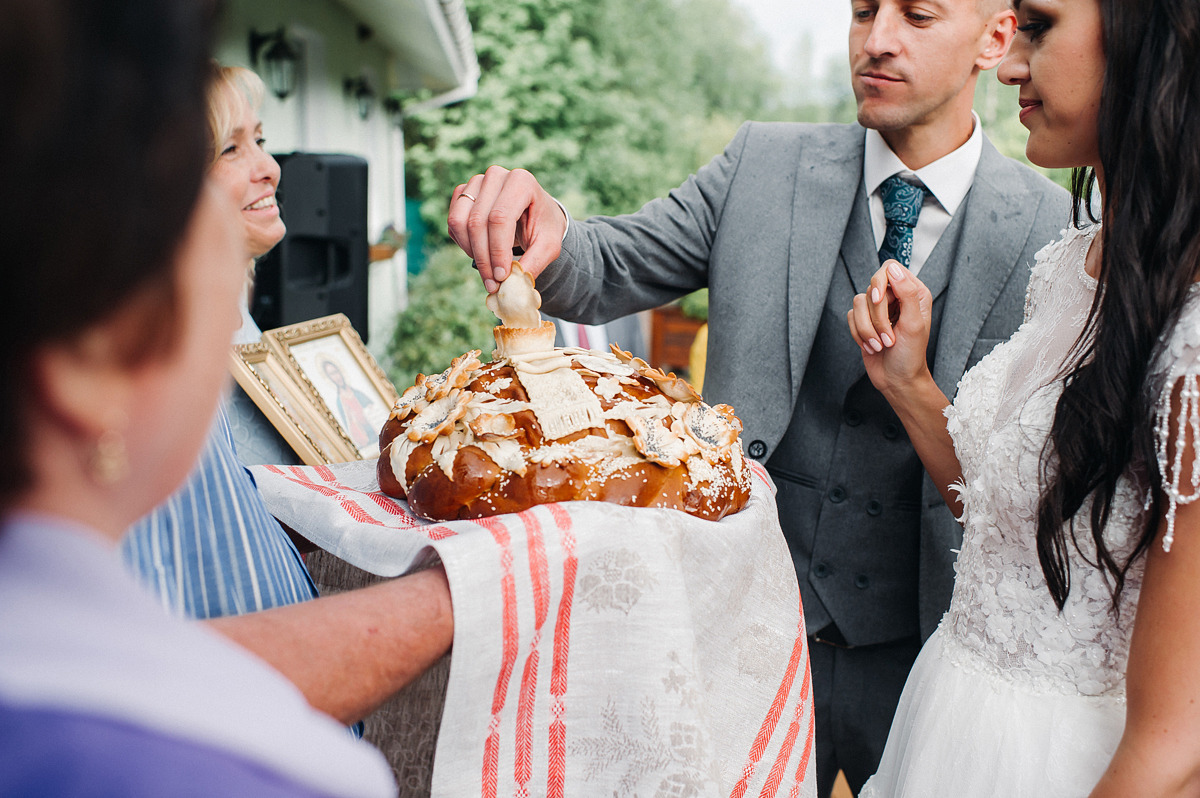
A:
<box><xmin>378</xmin><ymin>263</ymin><xmax>750</xmax><ymax>521</ymax></box>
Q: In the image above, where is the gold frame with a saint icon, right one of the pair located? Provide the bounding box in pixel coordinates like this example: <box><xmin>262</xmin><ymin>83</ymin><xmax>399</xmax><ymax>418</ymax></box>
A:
<box><xmin>263</xmin><ymin>313</ymin><xmax>397</xmax><ymax>460</ymax></box>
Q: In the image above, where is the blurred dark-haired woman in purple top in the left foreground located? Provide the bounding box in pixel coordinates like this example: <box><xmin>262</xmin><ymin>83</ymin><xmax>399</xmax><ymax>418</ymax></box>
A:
<box><xmin>0</xmin><ymin>0</ymin><xmax>394</xmax><ymax>796</ymax></box>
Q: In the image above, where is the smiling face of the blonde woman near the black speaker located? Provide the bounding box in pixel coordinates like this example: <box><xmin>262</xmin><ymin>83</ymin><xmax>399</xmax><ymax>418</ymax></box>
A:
<box><xmin>210</xmin><ymin>93</ymin><xmax>287</xmax><ymax>258</ymax></box>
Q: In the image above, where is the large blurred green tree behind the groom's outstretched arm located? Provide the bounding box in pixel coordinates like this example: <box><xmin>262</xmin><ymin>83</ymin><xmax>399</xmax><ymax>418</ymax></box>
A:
<box><xmin>404</xmin><ymin>0</ymin><xmax>776</xmax><ymax>240</ymax></box>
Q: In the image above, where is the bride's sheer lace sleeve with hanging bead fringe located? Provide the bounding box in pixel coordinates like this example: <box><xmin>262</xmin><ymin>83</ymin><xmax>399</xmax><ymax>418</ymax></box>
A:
<box><xmin>1150</xmin><ymin>291</ymin><xmax>1200</xmax><ymax>551</ymax></box>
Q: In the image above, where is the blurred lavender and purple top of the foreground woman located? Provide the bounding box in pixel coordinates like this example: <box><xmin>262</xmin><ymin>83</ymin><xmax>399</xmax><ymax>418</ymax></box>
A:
<box><xmin>0</xmin><ymin>512</ymin><xmax>396</xmax><ymax>798</ymax></box>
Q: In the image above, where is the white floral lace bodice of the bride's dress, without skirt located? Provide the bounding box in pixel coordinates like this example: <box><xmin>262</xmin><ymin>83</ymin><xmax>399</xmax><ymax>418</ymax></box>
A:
<box><xmin>942</xmin><ymin>229</ymin><xmax>1145</xmax><ymax>696</ymax></box>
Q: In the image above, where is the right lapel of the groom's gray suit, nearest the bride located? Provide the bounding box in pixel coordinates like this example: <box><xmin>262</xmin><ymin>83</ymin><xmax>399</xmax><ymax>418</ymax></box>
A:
<box><xmin>932</xmin><ymin>138</ymin><xmax>1040</xmax><ymax>395</ymax></box>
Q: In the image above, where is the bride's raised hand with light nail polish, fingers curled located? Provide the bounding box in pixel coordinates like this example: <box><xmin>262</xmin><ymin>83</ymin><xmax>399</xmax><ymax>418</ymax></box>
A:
<box><xmin>846</xmin><ymin>260</ymin><xmax>934</xmax><ymax>398</ymax></box>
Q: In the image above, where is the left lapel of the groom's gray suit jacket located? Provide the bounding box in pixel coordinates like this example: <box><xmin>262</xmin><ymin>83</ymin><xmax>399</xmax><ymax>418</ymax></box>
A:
<box><xmin>787</xmin><ymin>127</ymin><xmax>863</xmax><ymax>397</ymax></box>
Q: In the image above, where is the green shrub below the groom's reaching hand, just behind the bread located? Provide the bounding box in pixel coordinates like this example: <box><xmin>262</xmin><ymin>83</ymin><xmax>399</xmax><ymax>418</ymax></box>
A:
<box><xmin>388</xmin><ymin>245</ymin><xmax>499</xmax><ymax>392</ymax></box>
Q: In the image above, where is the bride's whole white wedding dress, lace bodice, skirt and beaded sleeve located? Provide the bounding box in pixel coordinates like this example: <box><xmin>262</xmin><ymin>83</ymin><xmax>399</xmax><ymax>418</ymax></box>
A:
<box><xmin>863</xmin><ymin>228</ymin><xmax>1200</xmax><ymax>797</ymax></box>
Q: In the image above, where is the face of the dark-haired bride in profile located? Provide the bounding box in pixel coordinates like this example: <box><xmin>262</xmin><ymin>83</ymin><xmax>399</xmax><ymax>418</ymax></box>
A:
<box><xmin>997</xmin><ymin>0</ymin><xmax>1105</xmax><ymax>168</ymax></box>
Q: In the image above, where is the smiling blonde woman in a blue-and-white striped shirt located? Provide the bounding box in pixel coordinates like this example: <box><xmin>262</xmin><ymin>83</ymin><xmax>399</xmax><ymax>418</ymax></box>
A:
<box><xmin>121</xmin><ymin>66</ymin><xmax>317</xmax><ymax>618</ymax></box>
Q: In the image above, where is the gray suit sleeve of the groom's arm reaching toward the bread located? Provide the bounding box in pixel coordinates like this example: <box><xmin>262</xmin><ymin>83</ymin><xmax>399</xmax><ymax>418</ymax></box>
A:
<box><xmin>538</xmin><ymin>124</ymin><xmax>749</xmax><ymax>324</ymax></box>
